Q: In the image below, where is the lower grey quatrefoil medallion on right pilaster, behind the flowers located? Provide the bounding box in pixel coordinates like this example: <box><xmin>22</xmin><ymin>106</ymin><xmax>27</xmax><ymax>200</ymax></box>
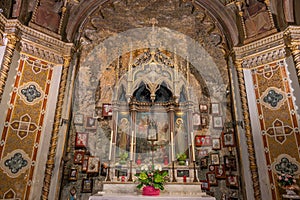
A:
<box><xmin>272</xmin><ymin>154</ymin><xmax>300</xmax><ymax>175</ymax></box>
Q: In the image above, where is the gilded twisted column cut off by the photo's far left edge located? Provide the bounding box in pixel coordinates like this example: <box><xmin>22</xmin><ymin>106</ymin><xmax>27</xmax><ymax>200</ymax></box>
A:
<box><xmin>0</xmin><ymin>34</ymin><xmax>18</xmax><ymax>103</ymax></box>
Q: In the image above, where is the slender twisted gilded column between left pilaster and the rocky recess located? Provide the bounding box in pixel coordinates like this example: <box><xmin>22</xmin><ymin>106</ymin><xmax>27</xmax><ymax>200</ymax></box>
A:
<box><xmin>41</xmin><ymin>56</ymin><xmax>71</xmax><ymax>200</ymax></box>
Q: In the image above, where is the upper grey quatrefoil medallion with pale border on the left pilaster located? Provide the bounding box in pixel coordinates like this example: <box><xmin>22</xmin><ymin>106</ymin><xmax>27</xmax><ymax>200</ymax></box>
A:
<box><xmin>18</xmin><ymin>82</ymin><xmax>44</xmax><ymax>105</ymax></box>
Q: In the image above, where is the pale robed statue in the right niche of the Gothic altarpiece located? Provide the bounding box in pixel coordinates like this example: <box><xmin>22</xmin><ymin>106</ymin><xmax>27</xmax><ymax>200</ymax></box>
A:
<box><xmin>175</xmin><ymin>118</ymin><xmax>188</xmax><ymax>154</ymax></box>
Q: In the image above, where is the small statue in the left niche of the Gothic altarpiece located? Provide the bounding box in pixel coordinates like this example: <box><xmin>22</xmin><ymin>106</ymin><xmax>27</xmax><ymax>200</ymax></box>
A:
<box><xmin>117</xmin><ymin>117</ymin><xmax>129</xmax><ymax>150</ymax></box>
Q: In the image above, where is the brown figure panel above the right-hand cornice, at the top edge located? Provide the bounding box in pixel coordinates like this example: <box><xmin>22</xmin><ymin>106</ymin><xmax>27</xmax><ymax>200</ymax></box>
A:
<box><xmin>244</xmin><ymin>0</ymin><xmax>272</xmax><ymax>38</ymax></box>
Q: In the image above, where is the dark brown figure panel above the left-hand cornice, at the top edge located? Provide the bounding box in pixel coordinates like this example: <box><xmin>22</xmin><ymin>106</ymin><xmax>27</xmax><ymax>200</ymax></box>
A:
<box><xmin>35</xmin><ymin>0</ymin><xmax>63</xmax><ymax>32</ymax></box>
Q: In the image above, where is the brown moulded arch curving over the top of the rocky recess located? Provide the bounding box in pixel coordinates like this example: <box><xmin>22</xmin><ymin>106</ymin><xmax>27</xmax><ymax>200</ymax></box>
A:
<box><xmin>66</xmin><ymin>0</ymin><xmax>239</xmax><ymax>48</ymax></box>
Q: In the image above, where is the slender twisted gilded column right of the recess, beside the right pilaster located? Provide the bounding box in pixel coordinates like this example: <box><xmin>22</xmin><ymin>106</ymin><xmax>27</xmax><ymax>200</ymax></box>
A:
<box><xmin>235</xmin><ymin>61</ymin><xmax>261</xmax><ymax>200</ymax></box>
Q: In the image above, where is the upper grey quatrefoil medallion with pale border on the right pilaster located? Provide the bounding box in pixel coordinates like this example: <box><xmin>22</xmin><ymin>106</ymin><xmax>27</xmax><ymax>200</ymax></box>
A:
<box><xmin>260</xmin><ymin>87</ymin><xmax>286</xmax><ymax>110</ymax></box>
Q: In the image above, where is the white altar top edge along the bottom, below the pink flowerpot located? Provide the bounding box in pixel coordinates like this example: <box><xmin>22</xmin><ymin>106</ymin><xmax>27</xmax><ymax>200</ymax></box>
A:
<box><xmin>89</xmin><ymin>194</ymin><xmax>216</xmax><ymax>200</ymax></box>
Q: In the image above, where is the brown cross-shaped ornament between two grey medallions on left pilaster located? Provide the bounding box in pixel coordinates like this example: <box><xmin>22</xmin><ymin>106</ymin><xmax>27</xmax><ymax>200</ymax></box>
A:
<box><xmin>10</xmin><ymin>114</ymin><xmax>38</xmax><ymax>140</ymax></box>
